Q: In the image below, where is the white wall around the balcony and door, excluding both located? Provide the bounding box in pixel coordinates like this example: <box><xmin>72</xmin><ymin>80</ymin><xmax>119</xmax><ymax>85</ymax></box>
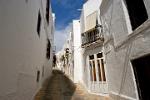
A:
<box><xmin>80</xmin><ymin>0</ymin><xmax>105</xmax><ymax>93</ymax></box>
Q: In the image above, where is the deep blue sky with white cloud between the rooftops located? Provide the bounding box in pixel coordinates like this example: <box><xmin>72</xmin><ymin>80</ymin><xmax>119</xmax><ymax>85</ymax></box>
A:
<box><xmin>51</xmin><ymin>0</ymin><xmax>85</xmax><ymax>51</ymax></box>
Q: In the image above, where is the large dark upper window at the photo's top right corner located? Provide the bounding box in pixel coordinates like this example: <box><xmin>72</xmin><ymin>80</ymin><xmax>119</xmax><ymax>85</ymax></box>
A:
<box><xmin>125</xmin><ymin>0</ymin><xmax>148</xmax><ymax>30</ymax></box>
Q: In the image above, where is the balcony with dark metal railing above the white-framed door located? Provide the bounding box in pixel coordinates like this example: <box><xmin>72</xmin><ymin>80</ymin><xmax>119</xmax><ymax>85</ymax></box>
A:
<box><xmin>81</xmin><ymin>25</ymin><xmax>104</xmax><ymax>48</ymax></box>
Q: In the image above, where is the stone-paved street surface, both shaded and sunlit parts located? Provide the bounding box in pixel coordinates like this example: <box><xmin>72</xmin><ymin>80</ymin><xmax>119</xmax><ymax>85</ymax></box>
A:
<box><xmin>35</xmin><ymin>70</ymin><xmax>109</xmax><ymax>100</ymax></box>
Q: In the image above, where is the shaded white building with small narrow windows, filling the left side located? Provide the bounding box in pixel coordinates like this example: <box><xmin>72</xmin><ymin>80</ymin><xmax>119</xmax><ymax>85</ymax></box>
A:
<box><xmin>0</xmin><ymin>0</ymin><xmax>54</xmax><ymax>100</ymax></box>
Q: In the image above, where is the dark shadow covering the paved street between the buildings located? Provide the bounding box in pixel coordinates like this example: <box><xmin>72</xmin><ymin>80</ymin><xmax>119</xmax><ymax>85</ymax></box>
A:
<box><xmin>35</xmin><ymin>70</ymin><xmax>76</xmax><ymax>100</ymax></box>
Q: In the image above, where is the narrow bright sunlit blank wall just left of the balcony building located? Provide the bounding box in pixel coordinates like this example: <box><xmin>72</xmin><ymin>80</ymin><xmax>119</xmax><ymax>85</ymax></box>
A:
<box><xmin>73</xmin><ymin>20</ymin><xmax>83</xmax><ymax>83</ymax></box>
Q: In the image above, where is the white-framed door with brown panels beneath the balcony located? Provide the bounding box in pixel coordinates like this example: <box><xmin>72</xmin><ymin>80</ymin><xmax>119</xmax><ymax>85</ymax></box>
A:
<box><xmin>89</xmin><ymin>53</ymin><xmax>107</xmax><ymax>93</ymax></box>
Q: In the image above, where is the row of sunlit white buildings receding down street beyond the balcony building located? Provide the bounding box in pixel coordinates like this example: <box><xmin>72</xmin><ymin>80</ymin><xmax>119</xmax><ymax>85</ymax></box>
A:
<box><xmin>56</xmin><ymin>20</ymin><xmax>83</xmax><ymax>83</ymax></box>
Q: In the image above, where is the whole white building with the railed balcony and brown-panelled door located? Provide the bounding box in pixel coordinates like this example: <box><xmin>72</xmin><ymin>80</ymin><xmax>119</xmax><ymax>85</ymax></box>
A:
<box><xmin>80</xmin><ymin>0</ymin><xmax>108</xmax><ymax>94</ymax></box>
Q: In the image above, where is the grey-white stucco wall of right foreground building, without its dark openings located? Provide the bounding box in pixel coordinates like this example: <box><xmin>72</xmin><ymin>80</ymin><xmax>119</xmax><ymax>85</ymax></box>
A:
<box><xmin>100</xmin><ymin>0</ymin><xmax>150</xmax><ymax>100</ymax></box>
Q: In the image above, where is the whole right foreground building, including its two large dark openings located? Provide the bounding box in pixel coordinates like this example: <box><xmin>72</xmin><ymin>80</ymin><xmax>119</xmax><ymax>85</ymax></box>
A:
<box><xmin>100</xmin><ymin>0</ymin><xmax>150</xmax><ymax>100</ymax></box>
